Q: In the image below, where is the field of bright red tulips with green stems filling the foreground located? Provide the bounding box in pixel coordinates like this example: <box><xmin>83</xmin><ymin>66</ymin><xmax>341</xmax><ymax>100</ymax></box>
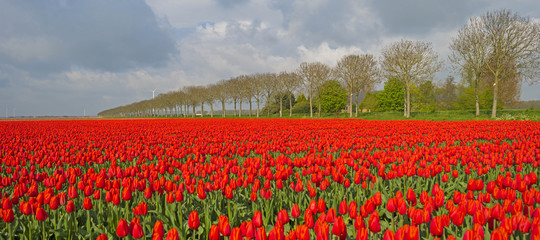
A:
<box><xmin>0</xmin><ymin>119</ymin><xmax>540</xmax><ymax>240</ymax></box>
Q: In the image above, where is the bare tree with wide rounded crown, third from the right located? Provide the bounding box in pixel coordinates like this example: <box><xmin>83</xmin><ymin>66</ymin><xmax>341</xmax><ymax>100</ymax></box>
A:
<box><xmin>381</xmin><ymin>40</ymin><xmax>442</xmax><ymax>118</ymax></box>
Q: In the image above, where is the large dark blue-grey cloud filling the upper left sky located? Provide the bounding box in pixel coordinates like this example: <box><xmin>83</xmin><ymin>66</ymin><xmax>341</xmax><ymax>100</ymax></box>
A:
<box><xmin>0</xmin><ymin>0</ymin><xmax>177</xmax><ymax>74</ymax></box>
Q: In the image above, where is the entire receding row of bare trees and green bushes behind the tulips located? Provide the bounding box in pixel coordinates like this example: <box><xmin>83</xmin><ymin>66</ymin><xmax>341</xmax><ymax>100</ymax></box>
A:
<box><xmin>98</xmin><ymin>9</ymin><xmax>540</xmax><ymax>118</ymax></box>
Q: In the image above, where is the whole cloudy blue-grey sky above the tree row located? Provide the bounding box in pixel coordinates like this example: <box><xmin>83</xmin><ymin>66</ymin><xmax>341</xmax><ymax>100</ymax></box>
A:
<box><xmin>0</xmin><ymin>0</ymin><xmax>540</xmax><ymax>117</ymax></box>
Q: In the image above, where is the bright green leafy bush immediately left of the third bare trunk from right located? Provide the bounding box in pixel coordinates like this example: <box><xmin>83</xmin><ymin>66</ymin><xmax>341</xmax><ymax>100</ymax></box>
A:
<box><xmin>377</xmin><ymin>77</ymin><xmax>405</xmax><ymax>111</ymax></box>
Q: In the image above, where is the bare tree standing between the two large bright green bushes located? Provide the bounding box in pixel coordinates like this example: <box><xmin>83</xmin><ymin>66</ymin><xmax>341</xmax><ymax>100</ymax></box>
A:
<box><xmin>335</xmin><ymin>54</ymin><xmax>381</xmax><ymax>117</ymax></box>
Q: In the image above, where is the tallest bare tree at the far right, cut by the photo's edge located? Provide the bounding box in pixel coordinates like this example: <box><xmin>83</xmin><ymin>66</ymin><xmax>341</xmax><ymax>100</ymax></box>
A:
<box><xmin>481</xmin><ymin>10</ymin><xmax>540</xmax><ymax>118</ymax></box>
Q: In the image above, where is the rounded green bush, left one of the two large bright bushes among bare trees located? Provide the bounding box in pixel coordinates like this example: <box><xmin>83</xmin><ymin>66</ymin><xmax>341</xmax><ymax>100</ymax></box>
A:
<box><xmin>319</xmin><ymin>80</ymin><xmax>347</xmax><ymax>113</ymax></box>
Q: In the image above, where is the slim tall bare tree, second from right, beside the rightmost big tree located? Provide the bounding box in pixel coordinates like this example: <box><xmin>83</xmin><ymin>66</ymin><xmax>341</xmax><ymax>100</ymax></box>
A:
<box><xmin>449</xmin><ymin>18</ymin><xmax>488</xmax><ymax>116</ymax></box>
